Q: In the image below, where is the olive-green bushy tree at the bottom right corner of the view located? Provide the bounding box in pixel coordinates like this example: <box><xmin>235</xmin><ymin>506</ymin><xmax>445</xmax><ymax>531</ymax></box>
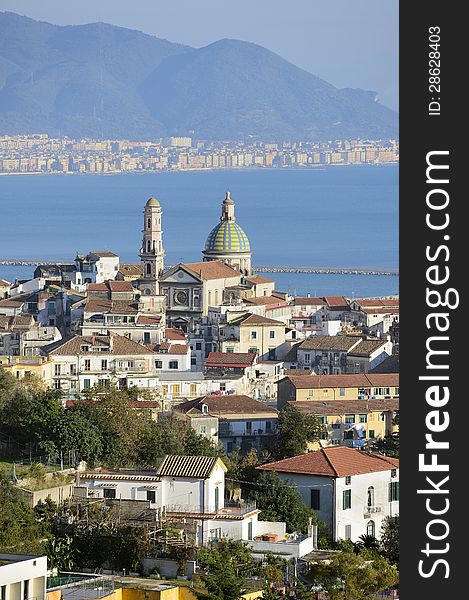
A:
<box><xmin>310</xmin><ymin>552</ymin><xmax>399</xmax><ymax>600</ymax></box>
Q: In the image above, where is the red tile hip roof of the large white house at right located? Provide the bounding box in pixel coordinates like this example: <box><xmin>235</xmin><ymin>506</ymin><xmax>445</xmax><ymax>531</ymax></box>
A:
<box><xmin>257</xmin><ymin>446</ymin><xmax>399</xmax><ymax>477</ymax></box>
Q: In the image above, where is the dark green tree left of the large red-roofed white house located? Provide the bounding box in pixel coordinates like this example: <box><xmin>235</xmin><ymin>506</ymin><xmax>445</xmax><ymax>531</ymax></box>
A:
<box><xmin>249</xmin><ymin>471</ymin><xmax>317</xmax><ymax>533</ymax></box>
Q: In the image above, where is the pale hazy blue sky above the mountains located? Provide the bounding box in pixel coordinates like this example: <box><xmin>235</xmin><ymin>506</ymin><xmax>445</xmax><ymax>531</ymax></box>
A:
<box><xmin>0</xmin><ymin>0</ymin><xmax>399</xmax><ymax>110</ymax></box>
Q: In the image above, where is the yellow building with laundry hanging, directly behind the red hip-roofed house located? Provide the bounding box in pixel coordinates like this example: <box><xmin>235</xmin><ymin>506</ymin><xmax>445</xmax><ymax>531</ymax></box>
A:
<box><xmin>290</xmin><ymin>398</ymin><xmax>399</xmax><ymax>450</ymax></box>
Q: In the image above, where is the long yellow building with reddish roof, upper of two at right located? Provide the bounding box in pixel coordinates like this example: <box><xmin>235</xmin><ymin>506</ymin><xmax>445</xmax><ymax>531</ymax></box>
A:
<box><xmin>277</xmin><ymin>373</ymin><xmax>399</xmax><ymax>408</ymax></box>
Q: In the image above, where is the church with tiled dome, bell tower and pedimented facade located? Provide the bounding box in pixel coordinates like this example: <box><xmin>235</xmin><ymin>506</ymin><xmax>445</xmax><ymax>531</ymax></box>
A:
<box><xmin>136</xmin><ymin>192</ymin><xmax>274</xmax><ymax>332</ymax></box>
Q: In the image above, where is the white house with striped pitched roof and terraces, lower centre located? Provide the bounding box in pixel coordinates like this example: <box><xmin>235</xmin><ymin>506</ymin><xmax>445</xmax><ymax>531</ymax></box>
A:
<box><xmin>76</xmin><ymin>455</ymin><xmax>314</xmax><ymax>558</ymax></box>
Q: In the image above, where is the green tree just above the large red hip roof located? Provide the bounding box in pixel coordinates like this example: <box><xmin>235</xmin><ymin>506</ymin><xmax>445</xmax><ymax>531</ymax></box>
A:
<box><xmin>272</xmin><ymin>404</ymin><xmax>324</xmax><ymax>460</ymax></box>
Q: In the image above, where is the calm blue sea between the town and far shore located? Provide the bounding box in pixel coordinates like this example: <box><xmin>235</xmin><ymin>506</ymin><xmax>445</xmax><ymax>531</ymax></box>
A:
<box><xmin>0</xmin><ymin>164</ymin><xmax>399</xmax><ymax>297</ymax></box>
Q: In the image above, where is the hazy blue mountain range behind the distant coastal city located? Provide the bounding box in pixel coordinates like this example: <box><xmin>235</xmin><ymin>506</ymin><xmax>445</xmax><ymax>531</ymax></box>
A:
<box><xmin>0</xmin><ymin>12</ymin><xmax>398</xmax><ymax>140</ymax></box>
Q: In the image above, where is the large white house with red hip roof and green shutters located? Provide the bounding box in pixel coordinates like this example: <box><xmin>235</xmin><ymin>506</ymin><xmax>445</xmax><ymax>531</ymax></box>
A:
<box><xmin>257</xmin><ymin>446</ymin><xmax>399</xmax><ymax>542</ymax></box>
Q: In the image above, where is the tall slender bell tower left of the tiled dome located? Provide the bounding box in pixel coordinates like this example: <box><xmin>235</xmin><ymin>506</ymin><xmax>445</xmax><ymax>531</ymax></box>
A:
<box><xmin>138</xmin><ymin>198</ymin><xmax>164</xmax><ymax>296</ymax></box>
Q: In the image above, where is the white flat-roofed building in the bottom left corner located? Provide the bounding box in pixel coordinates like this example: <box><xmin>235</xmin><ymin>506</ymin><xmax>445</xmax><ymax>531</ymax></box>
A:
<box><xmin>0</xmin><ymin>554</ymin><xmax>47</xmax><ymax>600</ymax></box>
